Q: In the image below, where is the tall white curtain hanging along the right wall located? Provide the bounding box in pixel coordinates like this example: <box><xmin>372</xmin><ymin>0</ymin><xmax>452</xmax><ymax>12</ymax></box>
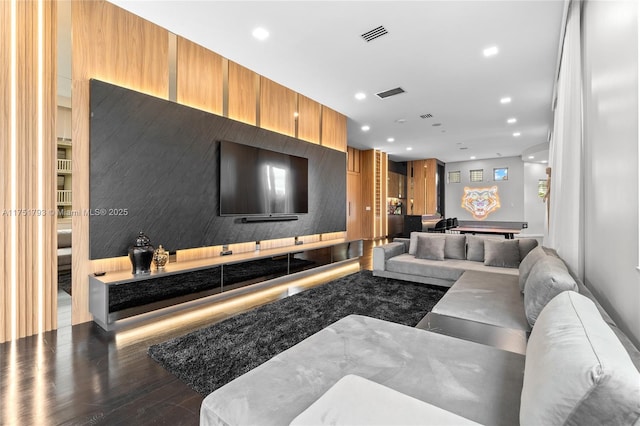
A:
<box><xmin>544</xmin><ymin>0</ymin><xmax>584</xmax><ymax>279</ymax></box>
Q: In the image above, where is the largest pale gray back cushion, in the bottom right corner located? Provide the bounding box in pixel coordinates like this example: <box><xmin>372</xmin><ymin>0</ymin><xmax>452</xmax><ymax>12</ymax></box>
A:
<box><xmin>520</xmin><ymin>291</ymin><xmax>640</xmax><ymax>425</ymax></box>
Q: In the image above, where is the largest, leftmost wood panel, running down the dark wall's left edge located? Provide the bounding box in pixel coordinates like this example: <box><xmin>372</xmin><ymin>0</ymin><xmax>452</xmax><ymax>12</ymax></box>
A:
<box><xmin>72</xmin><ymin>0</ymin><xmax>169</xmax><ymax>324</ymax></box>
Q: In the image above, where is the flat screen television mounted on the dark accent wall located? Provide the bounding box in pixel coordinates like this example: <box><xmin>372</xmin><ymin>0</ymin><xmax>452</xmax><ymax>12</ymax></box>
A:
<box><xmin>220</xmin><ymin>141</ymin><xmax>309</xmax><ymax>216</ymax></box>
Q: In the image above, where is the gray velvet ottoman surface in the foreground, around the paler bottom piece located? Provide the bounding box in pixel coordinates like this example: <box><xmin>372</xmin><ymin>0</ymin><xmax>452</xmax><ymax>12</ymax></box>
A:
<box><xmin>200</xmin><ymin>315</ymin><xmax>525</xmax><ymax>425</ymax></box>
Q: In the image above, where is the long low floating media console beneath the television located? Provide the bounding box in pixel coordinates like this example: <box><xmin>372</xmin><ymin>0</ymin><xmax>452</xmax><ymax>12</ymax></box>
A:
<box><xmin>89</xmin><ymin>240</ymin><xmax>362</xmax><ymax>331</ymax></box>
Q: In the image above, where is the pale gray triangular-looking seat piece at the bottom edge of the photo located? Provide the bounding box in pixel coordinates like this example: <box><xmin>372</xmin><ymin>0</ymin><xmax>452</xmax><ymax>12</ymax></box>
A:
<box><xmin>289</xmin><ymin>374</ymin><xmax>478</xmax><ymax>426</ymax></box>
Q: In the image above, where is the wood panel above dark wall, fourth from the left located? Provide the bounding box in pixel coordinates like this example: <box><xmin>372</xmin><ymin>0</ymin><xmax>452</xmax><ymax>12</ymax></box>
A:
<box><xmin>260</xmin><ymin>77</ymin><xmax>296</xmax><ymax>137</ymax></box>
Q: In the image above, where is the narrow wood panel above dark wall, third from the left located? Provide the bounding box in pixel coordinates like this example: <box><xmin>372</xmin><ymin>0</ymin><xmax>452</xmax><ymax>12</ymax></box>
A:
<box><xmin>228</xmin><ymin>61</ymin><xmax>259</xmax><ymax>125</ymax></box>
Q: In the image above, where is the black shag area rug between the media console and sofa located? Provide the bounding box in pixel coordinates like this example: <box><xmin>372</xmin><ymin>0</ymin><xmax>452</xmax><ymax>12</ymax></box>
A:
<box><xmin>149</xmin><ymin>271</ymin><xmax>447</xmax><ymax>395</ymax></box>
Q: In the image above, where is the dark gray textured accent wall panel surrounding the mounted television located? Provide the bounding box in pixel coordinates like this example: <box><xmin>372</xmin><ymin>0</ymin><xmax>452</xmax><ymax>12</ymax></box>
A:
<box><xmin>89</xmin><ymin>80</ymin><xmax>346</xmax><ymax>259</ymax></box>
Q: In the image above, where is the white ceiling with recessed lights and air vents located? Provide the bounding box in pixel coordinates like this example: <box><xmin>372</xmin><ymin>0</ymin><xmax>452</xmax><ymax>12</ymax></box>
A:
<box><xmin>106</xmin><ymin>0</ymin><xmax>564</xmax><ymax>162</ymax></box>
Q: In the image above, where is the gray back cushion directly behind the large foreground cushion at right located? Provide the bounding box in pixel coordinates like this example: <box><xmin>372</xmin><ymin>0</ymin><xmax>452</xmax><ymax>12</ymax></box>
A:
<box><xmin>524</xmin><ymin>256</ymin><xmax>578</xmax><ymax>326</ymax></box>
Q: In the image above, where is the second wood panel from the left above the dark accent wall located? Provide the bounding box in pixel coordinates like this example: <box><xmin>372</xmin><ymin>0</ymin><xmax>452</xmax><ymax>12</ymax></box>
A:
<box><xmin>177</xmin><ymin>37</ymin><xmax>223</xmax><ymax>115</ymax></box>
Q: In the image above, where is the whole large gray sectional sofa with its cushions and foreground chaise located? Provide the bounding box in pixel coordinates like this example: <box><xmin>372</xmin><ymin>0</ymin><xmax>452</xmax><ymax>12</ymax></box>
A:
<box><xmin>201</xmin><ymin>234</ymin><xmax>640</xmax><ymax>425</ymax></box>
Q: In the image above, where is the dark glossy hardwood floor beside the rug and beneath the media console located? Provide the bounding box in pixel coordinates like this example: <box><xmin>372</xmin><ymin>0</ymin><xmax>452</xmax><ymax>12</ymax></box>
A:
<box><xmin>0</xmin><ymin>241</ymin><xmax>379</xmax><ymax>425</ymax></box>
